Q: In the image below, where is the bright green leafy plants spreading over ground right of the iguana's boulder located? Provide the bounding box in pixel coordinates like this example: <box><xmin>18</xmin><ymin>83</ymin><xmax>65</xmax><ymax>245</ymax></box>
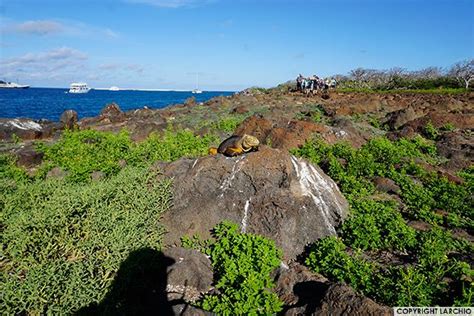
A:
<box><xmin>294</xmin><ymin>136</ymin><xmax>474</xmax><ymax>306</ymax></box>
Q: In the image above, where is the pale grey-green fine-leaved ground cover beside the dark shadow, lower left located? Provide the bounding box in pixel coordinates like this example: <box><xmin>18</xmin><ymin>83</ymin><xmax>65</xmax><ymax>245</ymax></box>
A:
<box><xmin>0</xmin><ymin>167</ymin><xmax>171</xmax><ymax>315</ymax></box>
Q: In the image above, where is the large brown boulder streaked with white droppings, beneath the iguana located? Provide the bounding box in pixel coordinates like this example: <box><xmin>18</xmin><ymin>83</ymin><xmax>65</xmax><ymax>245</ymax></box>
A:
<box><xmin>156</xmin><ymin>146</ymin><xmax>348</xmax><ymax>260</ymax></box>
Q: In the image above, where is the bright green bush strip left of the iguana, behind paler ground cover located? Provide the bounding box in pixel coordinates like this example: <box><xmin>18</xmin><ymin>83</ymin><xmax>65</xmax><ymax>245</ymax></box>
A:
<box><xmin>38</xmin><ymin>129</ymin><xmax>215</xmax><ymax>182</ymax></box>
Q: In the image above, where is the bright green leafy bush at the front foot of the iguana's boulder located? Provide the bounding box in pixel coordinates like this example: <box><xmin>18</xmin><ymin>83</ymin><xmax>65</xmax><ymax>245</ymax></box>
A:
<box><xmin>184</xmin><ymin>221</ymin><xmax>282</xmax><ymax>315</ymax></box>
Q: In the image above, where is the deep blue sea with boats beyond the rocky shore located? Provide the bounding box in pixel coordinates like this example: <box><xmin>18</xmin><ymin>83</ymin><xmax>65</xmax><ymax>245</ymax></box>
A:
<box><xmin>0</xmin><ymin>88</ymin><xmax>234</xmax><ymax>121</ymax></box>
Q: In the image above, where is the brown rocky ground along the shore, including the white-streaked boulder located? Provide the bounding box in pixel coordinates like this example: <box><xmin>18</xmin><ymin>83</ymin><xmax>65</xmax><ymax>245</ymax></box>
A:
<box><xmin>0</xmin><ymin>89</ymin><xmax>474</xmax><ymax>315</ymax></box>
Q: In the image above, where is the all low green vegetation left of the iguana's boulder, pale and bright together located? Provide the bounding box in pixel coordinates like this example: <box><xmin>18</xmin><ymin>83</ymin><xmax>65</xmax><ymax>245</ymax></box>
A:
<box><xmin>0</xmin><ymin>129</ymin><xmax>215</xmax><ymax>315</ymax></box>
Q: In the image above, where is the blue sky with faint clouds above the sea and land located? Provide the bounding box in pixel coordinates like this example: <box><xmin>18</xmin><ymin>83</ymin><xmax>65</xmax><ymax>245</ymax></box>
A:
<box><xmin>0</xmin><ymin>0</ymin><xmax>474</xmax><ymax>90</ymax></box>
